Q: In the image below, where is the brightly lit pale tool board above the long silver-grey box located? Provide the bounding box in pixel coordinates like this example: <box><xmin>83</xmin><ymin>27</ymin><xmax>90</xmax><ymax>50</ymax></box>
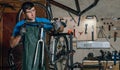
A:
<box><xmin>63</xmin><ymin>16</ymin><xmax>97</xmax><ymax>41</ymax></box>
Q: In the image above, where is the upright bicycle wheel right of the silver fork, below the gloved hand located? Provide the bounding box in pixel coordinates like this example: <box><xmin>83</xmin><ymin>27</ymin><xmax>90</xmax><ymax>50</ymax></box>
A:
<box><xmin>54</xmin><ymin>36</ymin><xmax>70</xmax><ymax>70</ymax></box>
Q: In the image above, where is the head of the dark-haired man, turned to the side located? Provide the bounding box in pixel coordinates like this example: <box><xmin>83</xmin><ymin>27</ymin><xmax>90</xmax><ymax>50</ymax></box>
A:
<box><xmin>22</xmin><ymin>2</ymin><xmax>36</xmax><ymax>21</ymax></box>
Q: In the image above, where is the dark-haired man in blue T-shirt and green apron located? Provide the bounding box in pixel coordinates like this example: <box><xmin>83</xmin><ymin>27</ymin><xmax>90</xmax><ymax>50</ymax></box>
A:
<box><xmin>10</xmin><ymin>2</ymin><xmax>52</xmax><ymax>70</ymax></box>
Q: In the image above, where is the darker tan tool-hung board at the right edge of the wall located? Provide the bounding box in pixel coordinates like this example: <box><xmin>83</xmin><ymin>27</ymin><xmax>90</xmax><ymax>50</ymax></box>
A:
<box><xmin>97</xmin><ymin>18</ymin><xmax>120</xmax><ymax>39</ymax></box>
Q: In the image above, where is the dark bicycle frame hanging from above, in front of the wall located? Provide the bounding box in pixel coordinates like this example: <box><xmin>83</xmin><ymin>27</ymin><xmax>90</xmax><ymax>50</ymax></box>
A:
<box><xmin>47</xmin><ymin>0</ymin><xmax>99</xmax><ymax>26</ymax></box>
